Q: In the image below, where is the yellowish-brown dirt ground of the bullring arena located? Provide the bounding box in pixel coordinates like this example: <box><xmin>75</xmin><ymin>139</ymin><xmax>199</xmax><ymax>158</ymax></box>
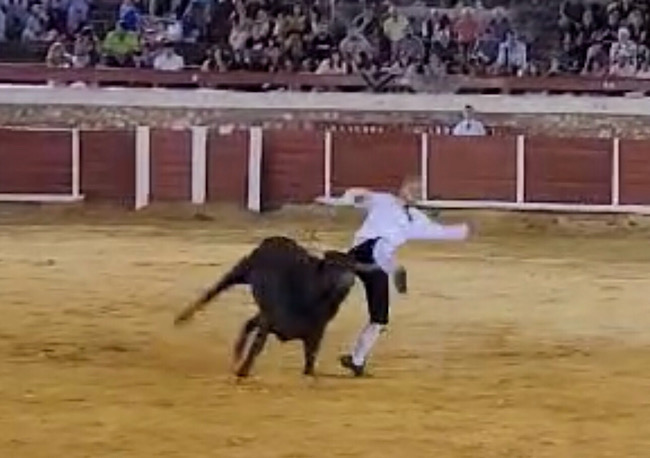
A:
<box><xmin>0</xmin><ymin>207</ymin><xmax>650</xmax><ymax>458</ymax></box>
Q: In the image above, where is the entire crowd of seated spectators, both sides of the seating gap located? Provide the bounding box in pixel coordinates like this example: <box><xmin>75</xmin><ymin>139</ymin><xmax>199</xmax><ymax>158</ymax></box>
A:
<box><xmin>5</xmin><ymin>0</ymin><xmax>650</xmax><ymax>84</ymax></box>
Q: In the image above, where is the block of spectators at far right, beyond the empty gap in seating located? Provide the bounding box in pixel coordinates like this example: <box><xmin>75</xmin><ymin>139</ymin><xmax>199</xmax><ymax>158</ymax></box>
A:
<box><xmin>551</xmin><ymin>0</ymin><xmax>650</xmax><ymax>78</ymax></box>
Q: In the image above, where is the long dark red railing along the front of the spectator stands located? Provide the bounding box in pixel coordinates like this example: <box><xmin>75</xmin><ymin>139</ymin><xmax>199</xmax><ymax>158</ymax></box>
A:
<box><xmin>0</xmin><ymin>64</ymin><xmax>650</xmax><ymax>95</ymax></box>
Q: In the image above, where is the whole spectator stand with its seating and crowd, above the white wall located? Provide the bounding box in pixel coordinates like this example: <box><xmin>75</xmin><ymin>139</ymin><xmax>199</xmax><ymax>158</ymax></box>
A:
<box><xmin>0</xmin><ymin>0</ymin><xmax>650</xmax><ymax>92</ymax></box>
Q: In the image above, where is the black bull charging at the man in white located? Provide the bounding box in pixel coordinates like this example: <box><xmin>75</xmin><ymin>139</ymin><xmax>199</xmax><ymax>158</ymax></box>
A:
<box><xmin>175</xmin><ymin>237</ymin><xmax>373</xmax><ymax>377</ymax></box>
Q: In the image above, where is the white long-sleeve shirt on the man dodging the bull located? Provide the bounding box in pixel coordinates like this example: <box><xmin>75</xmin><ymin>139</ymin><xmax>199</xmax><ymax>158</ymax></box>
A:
<box><xmin>323</xmin><ymin>189</ymin><xmax>469</xmax><ymax>275</ymax></box>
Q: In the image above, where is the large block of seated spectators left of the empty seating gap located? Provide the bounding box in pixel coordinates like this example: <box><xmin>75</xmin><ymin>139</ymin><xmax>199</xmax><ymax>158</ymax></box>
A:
<box><xmin>0</xmin><ymin>0</ymin><xmax>529</xmax><ymax>82</ymax></box>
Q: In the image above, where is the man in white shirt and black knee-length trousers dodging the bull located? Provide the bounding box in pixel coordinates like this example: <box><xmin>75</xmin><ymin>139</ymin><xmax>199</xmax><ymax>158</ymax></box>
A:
<box><xmin>316</xmin><ymin>178</ymin><xmax>469</xmax><ymax>377</ymax></box>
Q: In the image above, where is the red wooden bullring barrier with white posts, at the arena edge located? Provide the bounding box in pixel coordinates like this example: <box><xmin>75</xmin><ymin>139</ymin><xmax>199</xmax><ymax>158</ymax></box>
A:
<box><xmin>0</xmin><ymin>125</ymin><xmax>650</xmax><ymax>213</ymax></box>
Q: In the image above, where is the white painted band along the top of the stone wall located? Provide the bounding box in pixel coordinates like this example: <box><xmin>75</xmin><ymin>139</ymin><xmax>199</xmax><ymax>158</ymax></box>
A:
<box><xmin>0</xmin><ymin>86</ymin><xmax>650</xmax><ymax>116</ymax></box>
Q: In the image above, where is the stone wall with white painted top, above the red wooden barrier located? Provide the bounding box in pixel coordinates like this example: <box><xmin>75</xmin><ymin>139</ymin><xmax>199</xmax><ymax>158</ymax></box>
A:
<box><xmin>0</xmin><ymin>89</ymin><xmax>650</xmax><ymax>138</ymax></box>
